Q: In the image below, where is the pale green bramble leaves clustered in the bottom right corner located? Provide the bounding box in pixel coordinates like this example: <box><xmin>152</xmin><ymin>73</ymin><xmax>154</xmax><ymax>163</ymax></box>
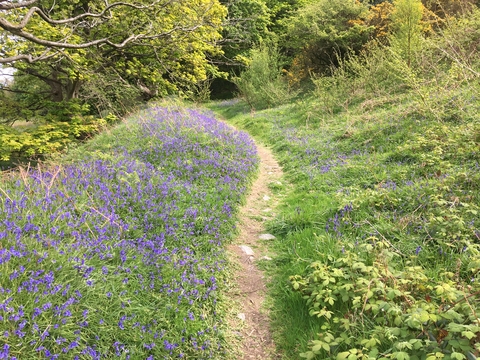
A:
<box><xmin>290</xmin><ymin>249</ymin><xmax>480</xmax><ymax>359</ymax></box>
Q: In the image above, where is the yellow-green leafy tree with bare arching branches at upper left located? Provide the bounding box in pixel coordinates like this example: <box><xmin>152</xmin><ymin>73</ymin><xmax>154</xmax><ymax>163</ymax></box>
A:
<box><xmin>0</xmin><ymin>0</ymin><xmax>226</xmax><ymax>112</ymax></box>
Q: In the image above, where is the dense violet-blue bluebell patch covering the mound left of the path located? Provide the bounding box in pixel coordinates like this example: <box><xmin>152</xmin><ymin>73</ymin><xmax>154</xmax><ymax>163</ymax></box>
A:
<box><xmin>0</xmin><ymin>107</ymin><xmax>257</xmax><ymax>359</ymax></box>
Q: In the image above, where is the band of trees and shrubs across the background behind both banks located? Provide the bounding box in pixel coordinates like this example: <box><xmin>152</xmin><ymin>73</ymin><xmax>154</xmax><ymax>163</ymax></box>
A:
<box><xmin>0</xmin><ymin>0</ymin><xmax>478</xmax><ymax>168</ymax></box>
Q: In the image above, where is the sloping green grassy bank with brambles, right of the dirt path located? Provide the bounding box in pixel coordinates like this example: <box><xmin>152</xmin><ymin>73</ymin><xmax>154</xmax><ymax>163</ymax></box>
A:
<box><xmin>210</xmin><ymin>92</ymin><xmax>480</xmax><ymax>359</ymax></box>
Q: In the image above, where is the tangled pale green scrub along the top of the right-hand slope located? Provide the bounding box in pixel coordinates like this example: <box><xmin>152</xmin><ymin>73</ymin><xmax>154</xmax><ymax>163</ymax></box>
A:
<box><xmin>313</xmin><ymin>9</ymin><xmax>480</xmax><ymax>122</ymax></box>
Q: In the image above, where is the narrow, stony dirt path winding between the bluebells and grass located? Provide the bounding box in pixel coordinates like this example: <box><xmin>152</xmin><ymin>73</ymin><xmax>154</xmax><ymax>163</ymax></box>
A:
<box><xmin>228</xmin><ymin>144</ymin><xmax>282</xmax><ymax>360</ymax></box>
